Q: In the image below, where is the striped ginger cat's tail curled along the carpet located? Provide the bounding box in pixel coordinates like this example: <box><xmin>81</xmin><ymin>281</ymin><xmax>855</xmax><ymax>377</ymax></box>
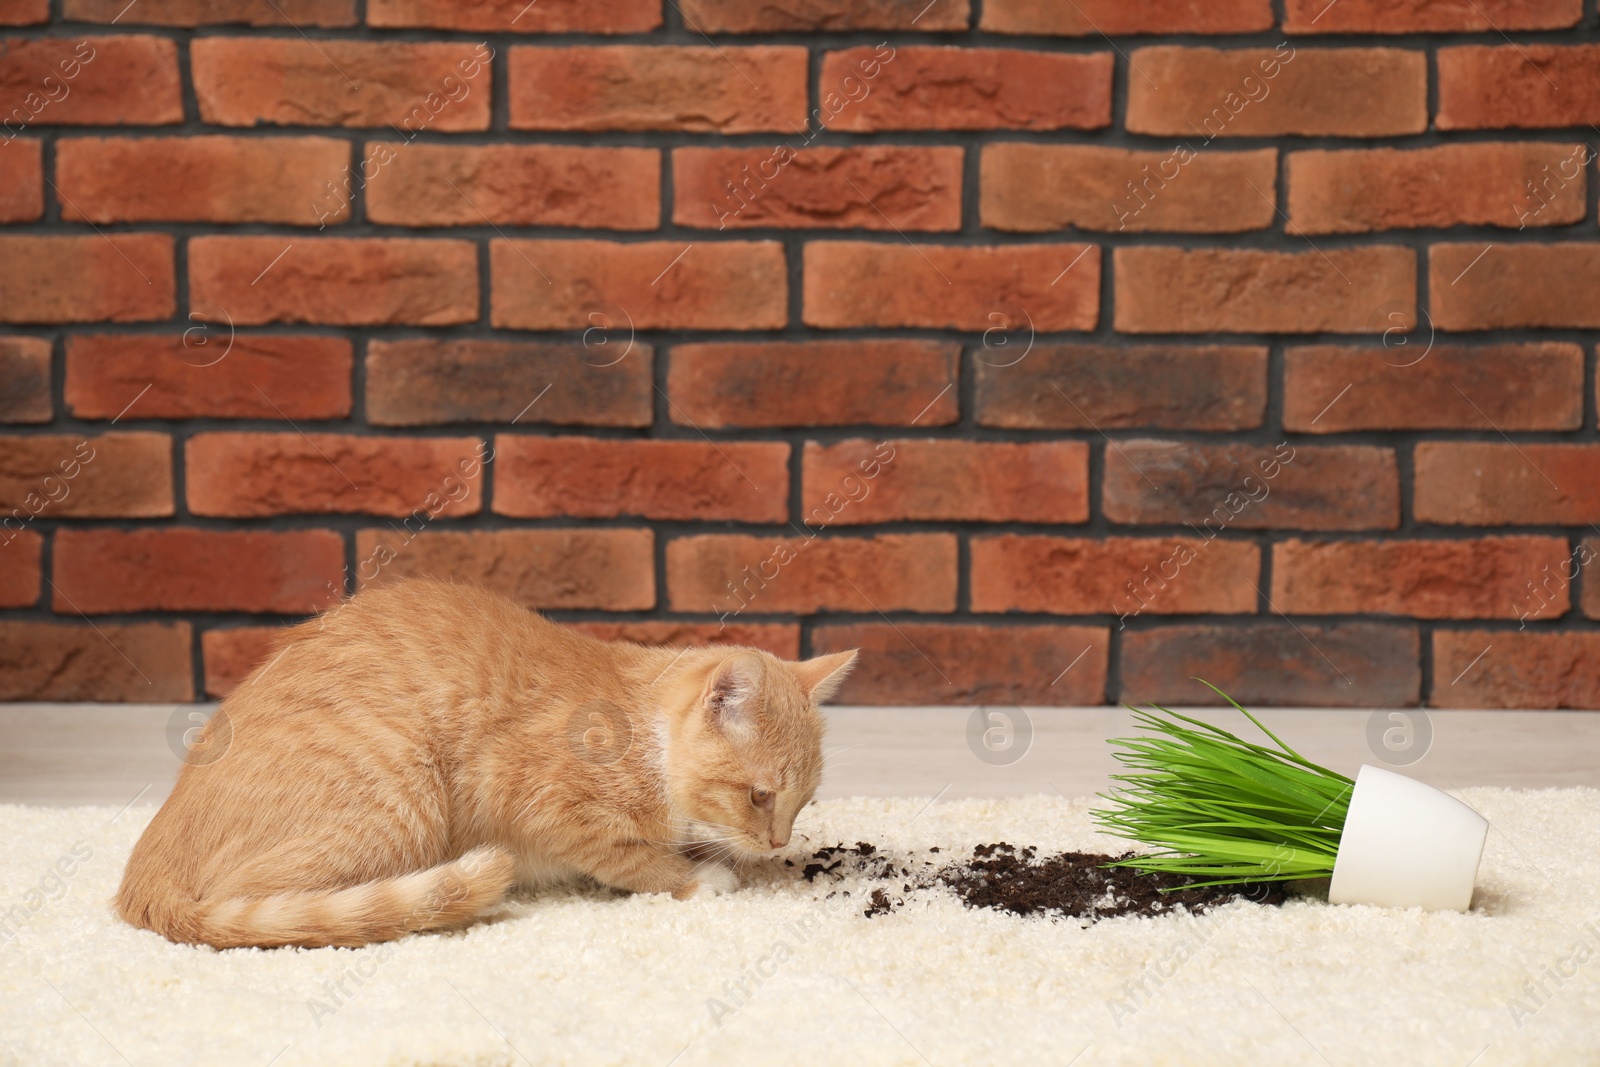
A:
<box><xmin>131</xmin><ymin>848</ymin><xmax>514</xmax><ymax>949</ymax></box>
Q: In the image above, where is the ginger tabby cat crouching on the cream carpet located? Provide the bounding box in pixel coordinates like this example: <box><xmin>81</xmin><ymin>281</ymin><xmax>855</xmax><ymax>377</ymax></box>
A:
<box><xmin>117</xmin><ymin>581</ymin><xmax>856</xmax><ymax>949</ymax></box>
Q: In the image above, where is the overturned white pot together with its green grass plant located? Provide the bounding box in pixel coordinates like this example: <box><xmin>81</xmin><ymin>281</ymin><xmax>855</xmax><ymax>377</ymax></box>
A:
<box><xmin>1094</xmin><ymin>686</ymin><xmax>1488</xmax><ymax>912</ymax></box>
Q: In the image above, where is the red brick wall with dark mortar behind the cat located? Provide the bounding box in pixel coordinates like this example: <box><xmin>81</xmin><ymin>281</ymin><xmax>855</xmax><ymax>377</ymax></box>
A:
<box><xmin>0</xmin><ymin>0</ymin><xmax>1600</xmax><ymax>707</ymax></box>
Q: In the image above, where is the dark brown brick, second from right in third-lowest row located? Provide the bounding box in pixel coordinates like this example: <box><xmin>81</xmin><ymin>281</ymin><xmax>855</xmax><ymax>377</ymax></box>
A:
<box><xmin>1102</xmin><ymin>440</ymin><xmax>1400</xmax><ymax>541</ymax></box>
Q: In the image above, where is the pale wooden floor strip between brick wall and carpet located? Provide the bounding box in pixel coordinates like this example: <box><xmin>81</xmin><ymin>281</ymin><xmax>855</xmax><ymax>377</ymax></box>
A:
<box><xmin>0</xmin><ymin>704</ymin><xmax>1600</xmax><ymax>806</ymax></box>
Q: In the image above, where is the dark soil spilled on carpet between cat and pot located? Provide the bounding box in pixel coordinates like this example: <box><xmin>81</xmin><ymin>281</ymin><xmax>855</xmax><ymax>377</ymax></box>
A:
<box><xmin>800</xmin><ymin>841</ymin><xmax>1285</xmax><ymax>921</ymax></box>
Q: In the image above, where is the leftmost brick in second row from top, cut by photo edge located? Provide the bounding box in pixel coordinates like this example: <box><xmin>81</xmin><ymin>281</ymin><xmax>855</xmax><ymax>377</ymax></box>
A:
<box><xmin>0</xmin><ymin>37</ymin><xmax>184</xmax><ymax>125</ymax></box>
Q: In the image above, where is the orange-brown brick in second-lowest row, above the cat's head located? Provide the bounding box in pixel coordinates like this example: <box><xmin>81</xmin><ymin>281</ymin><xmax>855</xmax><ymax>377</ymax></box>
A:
<box><xmin>667</xmin><ymin>533</ymin><xmax>957</xmax><ymax>622</ymax></box>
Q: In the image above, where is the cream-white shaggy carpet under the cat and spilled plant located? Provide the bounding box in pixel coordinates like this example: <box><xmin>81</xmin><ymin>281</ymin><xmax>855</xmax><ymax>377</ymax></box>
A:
<box><xmin>0</xmin><ymin>789</ymin><xmax>1600</xmax><ymax>1067</ymax></box>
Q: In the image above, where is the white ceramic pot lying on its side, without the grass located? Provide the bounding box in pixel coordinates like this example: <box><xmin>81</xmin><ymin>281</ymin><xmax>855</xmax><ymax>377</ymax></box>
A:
<box><xmin>1328</xmin><ymin>765</ymin><xmax>1490</xmax><ymax>912</ymax></box>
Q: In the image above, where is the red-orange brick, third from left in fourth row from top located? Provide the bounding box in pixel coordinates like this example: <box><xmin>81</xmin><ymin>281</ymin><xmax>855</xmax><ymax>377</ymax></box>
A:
<box><xmin>490</xmin><ymin>240</ymin><xmax>789</xmax><ymax>336</ymax></box>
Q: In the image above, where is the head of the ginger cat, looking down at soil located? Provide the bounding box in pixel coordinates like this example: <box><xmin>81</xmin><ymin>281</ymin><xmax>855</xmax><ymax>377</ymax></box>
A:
<box><xmin>667</xmin><ymin>649</ymin><xmax>856</xmax><ymax>856</ymax></box>
